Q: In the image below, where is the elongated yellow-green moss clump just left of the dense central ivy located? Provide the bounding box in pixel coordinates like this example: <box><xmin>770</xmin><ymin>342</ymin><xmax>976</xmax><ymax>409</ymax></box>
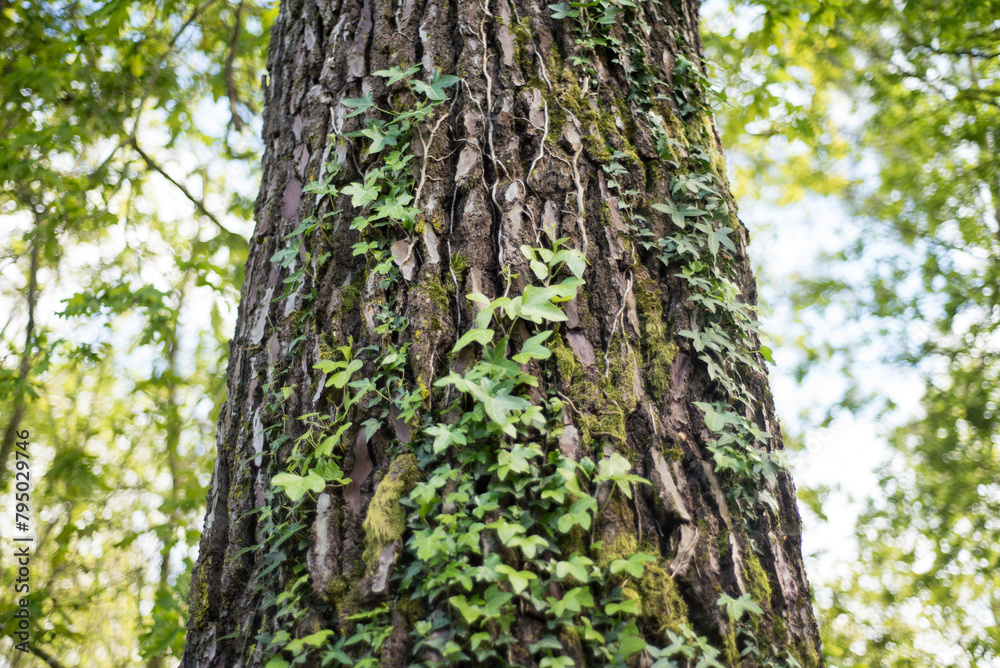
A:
<box><xmin>362</xmin><ymin>453</ymin><xmax>422</xmax><ymax>573</ymax></box>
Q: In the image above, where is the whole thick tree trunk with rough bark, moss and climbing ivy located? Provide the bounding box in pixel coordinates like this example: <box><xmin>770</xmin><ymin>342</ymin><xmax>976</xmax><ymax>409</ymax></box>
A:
<box><xmin>183</xmin><ymin>0</ymin><xmax>821</xmax><ymax>666</ymax></box>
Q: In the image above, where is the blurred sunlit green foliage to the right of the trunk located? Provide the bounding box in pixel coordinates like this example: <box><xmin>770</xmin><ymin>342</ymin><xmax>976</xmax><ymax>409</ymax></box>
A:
<box><xmin>706</xmin><ymin>0</ymin><xmax>1000</xmax><ymax>666</ymax></box>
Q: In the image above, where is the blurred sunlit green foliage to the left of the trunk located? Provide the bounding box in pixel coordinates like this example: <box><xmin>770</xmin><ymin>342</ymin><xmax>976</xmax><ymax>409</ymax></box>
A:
<box><xmin>0</xmin><ymin>0</ymin><xmax>276</xmax><ymax>665</ymax></box>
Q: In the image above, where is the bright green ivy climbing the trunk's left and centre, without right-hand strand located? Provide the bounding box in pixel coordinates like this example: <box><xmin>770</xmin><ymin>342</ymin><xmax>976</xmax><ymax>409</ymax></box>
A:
<box><xmin>250</xmin><ymin>54</ymin><xmax>764</xmax><ymax>668</ymax></box>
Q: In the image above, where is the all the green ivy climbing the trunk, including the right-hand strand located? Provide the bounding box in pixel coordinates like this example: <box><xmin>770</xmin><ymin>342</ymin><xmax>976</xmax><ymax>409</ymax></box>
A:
<box><xmin>250</xmin><ymin>20</ymin><xmax>799</xmax><ymax>668</ymax></box>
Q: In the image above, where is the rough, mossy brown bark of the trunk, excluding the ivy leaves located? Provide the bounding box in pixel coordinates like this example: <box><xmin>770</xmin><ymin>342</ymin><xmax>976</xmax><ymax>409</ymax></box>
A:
<box><xmin>183</xmin><ymin>0</ymin><xmax>821</xmax><ymax>666</ymax></box>
